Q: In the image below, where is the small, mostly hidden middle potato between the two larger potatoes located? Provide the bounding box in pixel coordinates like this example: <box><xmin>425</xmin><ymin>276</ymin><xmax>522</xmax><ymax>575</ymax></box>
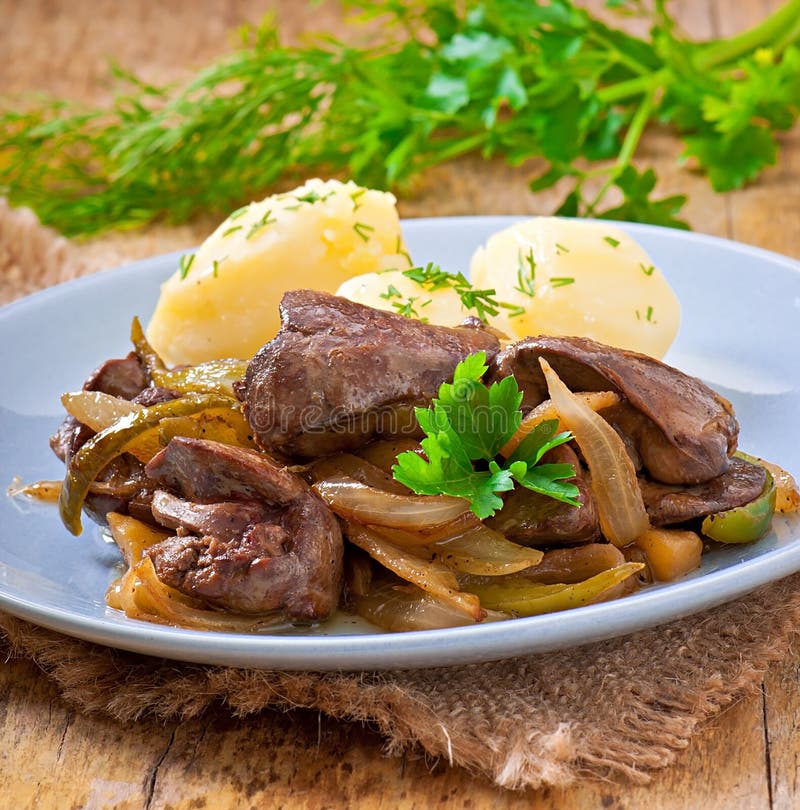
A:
<box><xmin>336</xmin><ymin>269</ymin><xmax>475</xmax><ymax>326</ymax></box>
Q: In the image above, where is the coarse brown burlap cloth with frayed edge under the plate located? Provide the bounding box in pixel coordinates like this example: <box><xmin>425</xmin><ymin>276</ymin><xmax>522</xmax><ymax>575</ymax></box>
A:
<box><xmin>0</xmin><ymin>199</ymin><xmax>800</xmax><ymax>788</ymax></box>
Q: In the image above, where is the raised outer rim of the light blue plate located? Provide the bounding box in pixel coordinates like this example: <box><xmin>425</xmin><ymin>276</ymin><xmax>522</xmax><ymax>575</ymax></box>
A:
<box><xmin>0</xmin><ymin>215</ymin><xmax>800</xmax><ymax>671</ymax></box>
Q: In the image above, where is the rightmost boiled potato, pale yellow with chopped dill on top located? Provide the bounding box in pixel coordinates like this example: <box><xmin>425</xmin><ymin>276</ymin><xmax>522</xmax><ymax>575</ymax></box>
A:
<box><xmin>471</xmin><ymin>217</ymin><xmax>680</xmax><ymax>358</ymax></box>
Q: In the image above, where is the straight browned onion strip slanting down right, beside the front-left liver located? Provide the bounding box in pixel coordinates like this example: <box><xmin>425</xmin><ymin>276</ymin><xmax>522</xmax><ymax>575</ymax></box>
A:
<box><xmin>345</xmin><ymin>523</ymin><xmax>483</xmax><ymax>621</ymax></box>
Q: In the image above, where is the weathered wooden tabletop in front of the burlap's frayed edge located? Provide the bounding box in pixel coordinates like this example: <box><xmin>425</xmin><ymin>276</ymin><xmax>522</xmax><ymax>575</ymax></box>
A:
<box><xmin>0</xmin><ymin>663</ymin><xmax>788</xmax><ymax>810</ymax></box>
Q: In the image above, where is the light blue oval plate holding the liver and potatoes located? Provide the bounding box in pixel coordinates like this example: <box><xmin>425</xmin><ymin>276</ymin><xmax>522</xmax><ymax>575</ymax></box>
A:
<box><xmin>0</xmin><ymin>217</ymin><xmax>800</xmax><ymax>670</ymax></box>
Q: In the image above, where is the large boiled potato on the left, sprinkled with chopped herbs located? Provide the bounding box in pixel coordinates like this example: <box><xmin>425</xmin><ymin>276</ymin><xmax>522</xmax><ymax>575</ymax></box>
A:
<box><xmin>147</xmin><ymin>180</ymin><xmax>410</xmax><ymax>365</ymax></box>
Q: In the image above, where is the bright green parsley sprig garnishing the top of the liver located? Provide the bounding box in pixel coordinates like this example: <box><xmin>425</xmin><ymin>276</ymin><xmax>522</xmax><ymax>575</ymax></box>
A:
<box><xmin>392</xmin><ymin>352</ymin><xmax>580</xmax><ymax>519</ymax></box>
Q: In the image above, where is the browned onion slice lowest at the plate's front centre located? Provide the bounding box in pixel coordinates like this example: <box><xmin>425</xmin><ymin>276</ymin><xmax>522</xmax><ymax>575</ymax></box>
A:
<box><xmin>353</xmin><ymin>583</ymin><xmax>510</xmax><ymax>632</ymax></box>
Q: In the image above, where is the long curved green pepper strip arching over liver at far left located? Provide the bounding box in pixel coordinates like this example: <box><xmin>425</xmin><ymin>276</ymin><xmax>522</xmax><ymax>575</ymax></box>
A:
<box><xmin>58</xmin><ymin>394</ymin><xmax>240</xmax><ymax>535</ymax></box>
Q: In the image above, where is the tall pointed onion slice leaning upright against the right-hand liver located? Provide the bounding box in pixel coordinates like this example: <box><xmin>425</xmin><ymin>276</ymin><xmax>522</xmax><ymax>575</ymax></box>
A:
<box><xmin>539</xmin><ymin>357</ymin><xmax>650</xmax><ymax>548</ymax></box>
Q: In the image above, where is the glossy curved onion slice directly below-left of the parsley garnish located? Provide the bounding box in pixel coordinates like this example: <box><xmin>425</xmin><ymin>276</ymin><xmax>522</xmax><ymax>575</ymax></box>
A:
<box><xmin>314</xmin><ymin>476</ymin><xmax>469</xmax><ymax>529</ymax></box>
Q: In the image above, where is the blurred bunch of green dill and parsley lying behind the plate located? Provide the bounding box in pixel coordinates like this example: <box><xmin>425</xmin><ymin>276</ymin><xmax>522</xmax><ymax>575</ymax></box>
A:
<box><xmin>0</xmin><ymin>0</ymin><xmax>800</xmax><ymax>234</ymax></box>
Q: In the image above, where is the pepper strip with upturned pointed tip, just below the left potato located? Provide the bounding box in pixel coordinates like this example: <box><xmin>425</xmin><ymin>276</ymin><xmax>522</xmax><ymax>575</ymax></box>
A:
<box><xmin>131</xmin><ymin>318</ymin><xmax>249</xmax><ymax>396</ymax></box>
